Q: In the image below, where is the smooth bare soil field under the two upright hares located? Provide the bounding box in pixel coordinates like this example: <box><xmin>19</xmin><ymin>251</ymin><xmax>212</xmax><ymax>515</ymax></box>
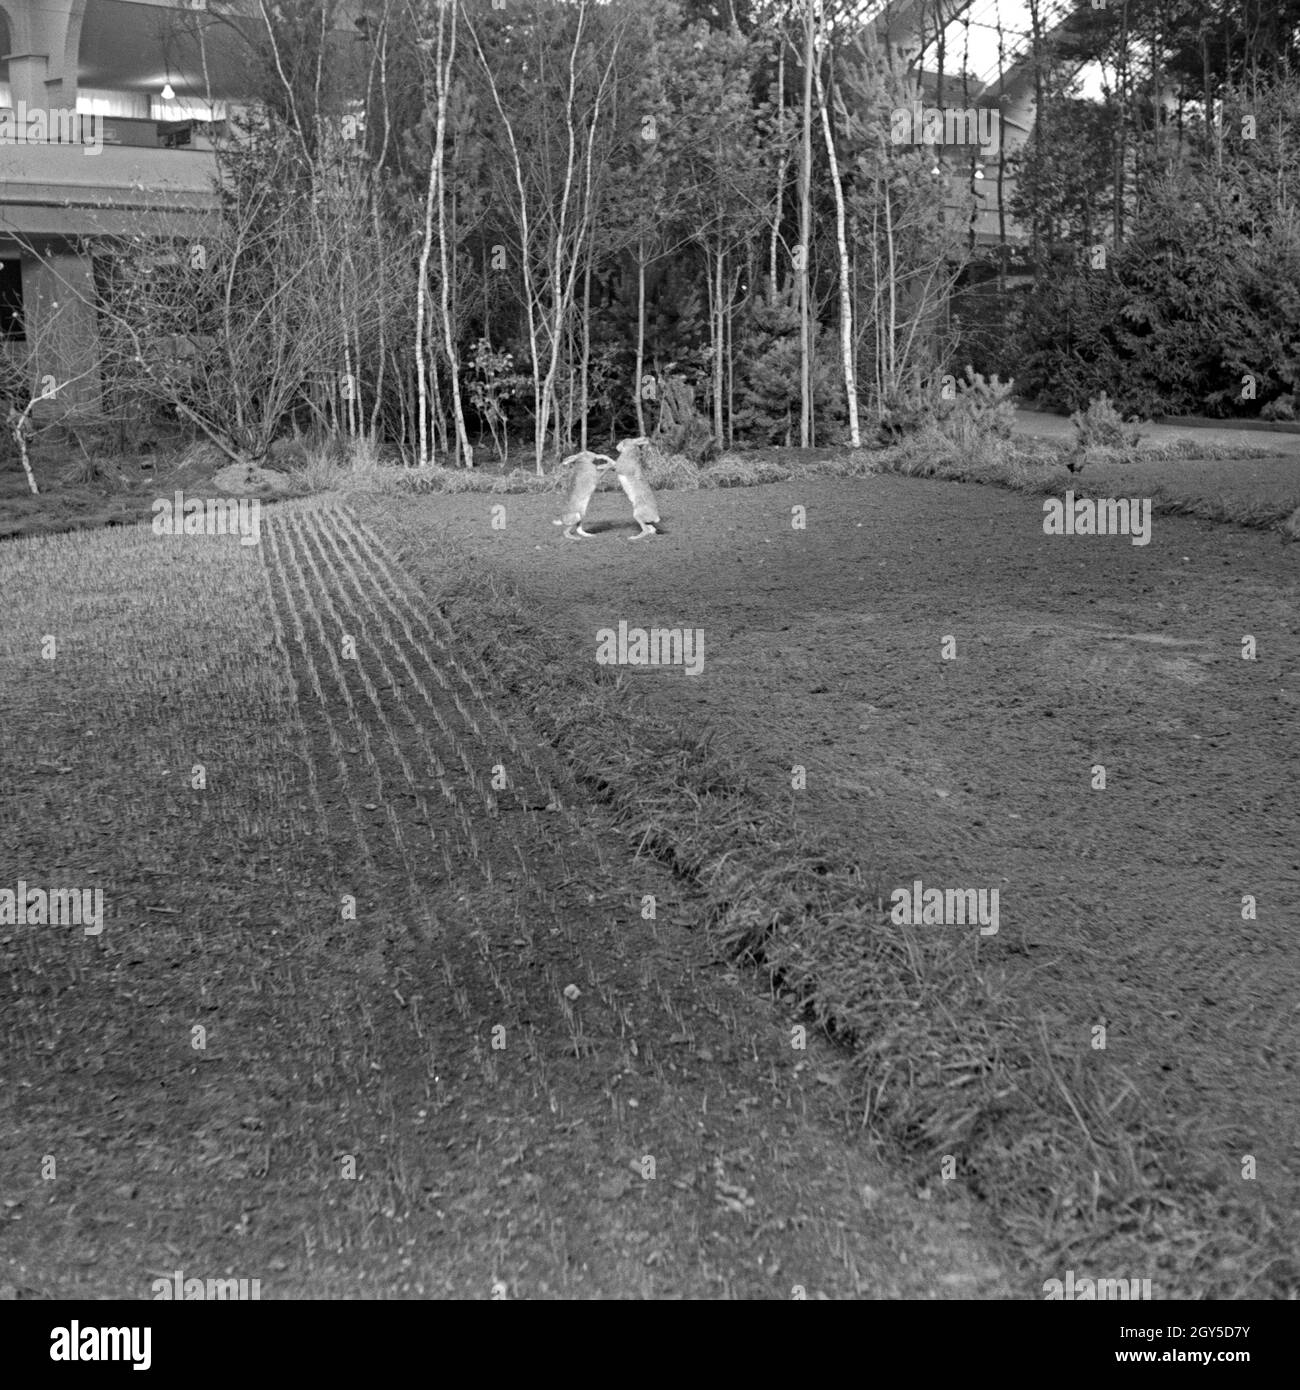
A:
<box><xmin>402</xmin><ymin>475</ymin><xmax>1300</xmax><ymax>1267</ymax></box>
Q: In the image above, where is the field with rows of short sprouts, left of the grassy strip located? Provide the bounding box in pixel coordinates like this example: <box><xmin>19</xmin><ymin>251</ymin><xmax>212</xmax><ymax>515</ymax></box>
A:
<box><xmin>0</xmin><ymin>506</ymin><xmax>1021</xmax><ymax>1298</ymax></box>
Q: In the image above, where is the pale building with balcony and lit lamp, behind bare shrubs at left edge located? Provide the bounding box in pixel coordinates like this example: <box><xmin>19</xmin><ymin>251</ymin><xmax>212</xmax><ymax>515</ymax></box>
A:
<box><xmin>0</xmin><ymin>0</ymin><xmax>254</xmax><ymax>409</ymax></box>
